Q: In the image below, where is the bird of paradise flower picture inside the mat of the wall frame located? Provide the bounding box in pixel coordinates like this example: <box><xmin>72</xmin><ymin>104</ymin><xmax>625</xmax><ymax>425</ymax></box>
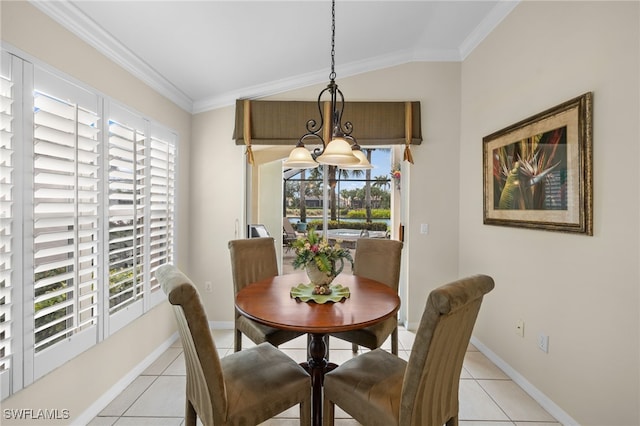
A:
<box><xmin>492</xmin><ymin>126</ymin><xmax>567</xmax><ymax>210</ymax></box>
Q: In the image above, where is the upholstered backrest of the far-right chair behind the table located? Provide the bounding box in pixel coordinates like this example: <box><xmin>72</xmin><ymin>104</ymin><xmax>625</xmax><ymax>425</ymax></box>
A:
<box><xmin>353</xmin><ymin>238</ymin><xmax>402</xmax><ymax>291</ymax></box>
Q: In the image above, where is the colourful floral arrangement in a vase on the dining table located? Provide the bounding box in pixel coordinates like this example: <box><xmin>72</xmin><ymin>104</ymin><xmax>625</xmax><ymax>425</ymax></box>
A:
<box><xmin>291</xmin><ymin>228</ymin><xmax>353</xmax><ymax>294</ymax></box>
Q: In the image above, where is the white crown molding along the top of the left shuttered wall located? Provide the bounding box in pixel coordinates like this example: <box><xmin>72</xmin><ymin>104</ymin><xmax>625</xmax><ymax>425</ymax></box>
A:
<box><xmin>29</xmin><ymin>0</ymin><xmax>193</xmax><ymax>113</ymax></box>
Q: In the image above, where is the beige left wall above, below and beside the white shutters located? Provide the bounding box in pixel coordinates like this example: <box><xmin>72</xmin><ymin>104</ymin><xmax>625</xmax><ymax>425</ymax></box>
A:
<box><xmin>1</xmin><ymin>1</ymin><xmax>191</xmax><ymax>424</ymax></box>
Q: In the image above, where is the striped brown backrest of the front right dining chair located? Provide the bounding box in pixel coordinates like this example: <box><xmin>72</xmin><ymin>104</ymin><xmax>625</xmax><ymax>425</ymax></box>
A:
<box><xmin>400</xmin><ymin>275</ymin><xmax>494</xmax><ymax>426</ymax></box>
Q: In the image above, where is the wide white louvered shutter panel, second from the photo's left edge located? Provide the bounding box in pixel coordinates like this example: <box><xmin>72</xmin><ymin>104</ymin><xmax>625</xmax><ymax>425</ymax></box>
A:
<box><xmin>33</xmin><ymin>66</ymin><xmax>100</xmax><ymax>377</ymax></box>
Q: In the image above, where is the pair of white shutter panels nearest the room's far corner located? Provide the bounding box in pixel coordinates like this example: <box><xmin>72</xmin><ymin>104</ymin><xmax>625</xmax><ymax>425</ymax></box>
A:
<box><xmin>107</xmin><ymin>103</ymin><xmax>175</xmax><ymax>332</ymax></box>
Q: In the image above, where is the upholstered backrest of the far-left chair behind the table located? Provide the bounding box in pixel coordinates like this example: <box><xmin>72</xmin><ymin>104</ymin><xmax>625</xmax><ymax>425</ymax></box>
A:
<box><xmin>229</xmin><ymin>237</ymin><xmax>278</xmax><ymax>293</ymax></box>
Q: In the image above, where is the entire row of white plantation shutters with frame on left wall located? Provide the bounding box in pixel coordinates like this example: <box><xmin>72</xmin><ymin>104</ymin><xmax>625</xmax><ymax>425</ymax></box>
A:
<box><xmin>0</xmin><ymin>48</ymin><xmax>177</xmax><ymax>400</ymax></box>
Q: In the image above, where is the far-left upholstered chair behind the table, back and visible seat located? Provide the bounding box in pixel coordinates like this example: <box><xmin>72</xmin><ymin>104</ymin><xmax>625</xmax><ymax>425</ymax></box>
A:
<box><xmin>229</xmin><ymin>237</ymin><xmax>304</xmax><ymax>352</ymax></box>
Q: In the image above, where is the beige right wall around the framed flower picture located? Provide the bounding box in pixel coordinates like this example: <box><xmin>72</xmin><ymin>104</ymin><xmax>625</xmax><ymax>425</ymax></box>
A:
<box><xmin>460</xmin><ymin>2</ymin><xmax>640</xmax><ymax>425</ymax></box>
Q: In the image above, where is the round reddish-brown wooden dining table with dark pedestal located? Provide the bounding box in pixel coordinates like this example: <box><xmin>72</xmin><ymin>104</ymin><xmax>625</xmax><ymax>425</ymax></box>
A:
<box><xmin>236</xmin><ymin>272</ymin><xmax>400</xmax><ymax>425</ymax></box>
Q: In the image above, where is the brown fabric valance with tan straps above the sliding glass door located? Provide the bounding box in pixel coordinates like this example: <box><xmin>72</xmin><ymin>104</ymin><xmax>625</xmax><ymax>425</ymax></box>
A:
<box><xmin>233</xmin><ymin>100</ymin><xmax>422</xmax><ymax>146</ymax></box>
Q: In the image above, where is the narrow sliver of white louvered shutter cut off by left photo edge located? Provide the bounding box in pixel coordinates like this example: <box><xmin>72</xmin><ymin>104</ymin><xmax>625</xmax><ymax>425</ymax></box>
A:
<box><xmin>0</xmin><ymin>52</ymin><xmax>16</xmax><ymax>399</ymax></box>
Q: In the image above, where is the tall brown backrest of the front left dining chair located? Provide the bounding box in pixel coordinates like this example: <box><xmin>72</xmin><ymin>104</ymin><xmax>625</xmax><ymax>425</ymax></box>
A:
<box><xmin>155</xmin><ymin>265</ymin><xmax>227</xmax><ymax>425</ymax></box>
